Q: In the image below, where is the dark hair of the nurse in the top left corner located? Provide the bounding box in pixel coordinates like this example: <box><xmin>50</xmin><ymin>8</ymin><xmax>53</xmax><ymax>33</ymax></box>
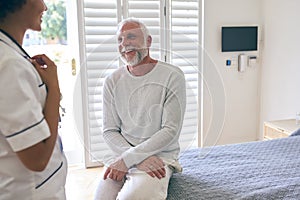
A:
<box><xmin>0</xmin><ymin>0</ymin><xmax>27</xmax><ymax>21</ymax></box>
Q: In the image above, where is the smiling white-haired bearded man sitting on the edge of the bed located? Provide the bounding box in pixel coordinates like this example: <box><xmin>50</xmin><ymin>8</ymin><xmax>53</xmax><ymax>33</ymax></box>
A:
<box><xmin>95</xmin><ymin>18</ymin><xmax>186</xmax><ymax>200</ymax></box>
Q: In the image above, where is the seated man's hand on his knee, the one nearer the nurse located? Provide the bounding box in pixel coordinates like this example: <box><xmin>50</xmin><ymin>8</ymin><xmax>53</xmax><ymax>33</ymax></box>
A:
<box><xmin>103</xmin><ymin>159</ymin><xmax>128</xmax><ymax>181</ymax></box>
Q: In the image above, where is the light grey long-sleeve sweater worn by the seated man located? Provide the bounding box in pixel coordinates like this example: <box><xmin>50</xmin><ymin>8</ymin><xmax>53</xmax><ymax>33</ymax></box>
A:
<box><xmin>103</xmin><ymin>61</ymin><xmax>186</xmax><ymax>170</ymax></box>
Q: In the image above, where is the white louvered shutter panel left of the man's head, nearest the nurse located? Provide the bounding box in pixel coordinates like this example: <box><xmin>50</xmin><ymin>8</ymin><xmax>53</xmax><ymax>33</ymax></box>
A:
<box><xmin>78</xmin><ymin>0</ymin><xmax>120</xmax><ymax>167</ymax></box>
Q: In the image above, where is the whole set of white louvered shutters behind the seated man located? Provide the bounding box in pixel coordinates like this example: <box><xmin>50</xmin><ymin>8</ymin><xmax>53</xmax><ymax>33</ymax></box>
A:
<box><xmin>78</xmin><ymin>0</ymin><xmax>199</xmax><ymax>167</ymax></box>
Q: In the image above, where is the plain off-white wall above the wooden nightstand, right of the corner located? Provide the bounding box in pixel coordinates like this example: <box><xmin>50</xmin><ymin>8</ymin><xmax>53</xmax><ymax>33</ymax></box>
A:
<box><xmin>260</xmin><ymin>0</ymin><xmax>300</xmax><ymax>132</ymax></box>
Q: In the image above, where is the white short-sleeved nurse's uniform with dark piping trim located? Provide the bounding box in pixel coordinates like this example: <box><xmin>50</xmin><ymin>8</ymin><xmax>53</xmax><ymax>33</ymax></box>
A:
<box><xmin>0</xmin><ymin>32</ymin><xmax>67</xmax><ymax>200</ymax></box>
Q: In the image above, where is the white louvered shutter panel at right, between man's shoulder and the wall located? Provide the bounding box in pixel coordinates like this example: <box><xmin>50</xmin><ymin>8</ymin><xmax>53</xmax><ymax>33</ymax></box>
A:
<box><xmin>167</xmin><ymin>0</ymin><xmax>199</xmax><ymax>151</ymax></box>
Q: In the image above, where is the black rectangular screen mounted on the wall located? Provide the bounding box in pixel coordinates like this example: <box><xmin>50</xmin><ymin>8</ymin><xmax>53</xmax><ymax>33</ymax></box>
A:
<box><xmin>222</xmin><ymin>26</ymin><xmax>258</xmax><ymax>52</ymax></box>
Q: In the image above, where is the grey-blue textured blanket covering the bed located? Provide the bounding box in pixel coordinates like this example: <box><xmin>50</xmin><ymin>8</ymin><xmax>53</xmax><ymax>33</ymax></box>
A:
<box><xmin>167</xmin><ymin>136</ymin><xmax>300</xmax><ymax>200</ymax></box>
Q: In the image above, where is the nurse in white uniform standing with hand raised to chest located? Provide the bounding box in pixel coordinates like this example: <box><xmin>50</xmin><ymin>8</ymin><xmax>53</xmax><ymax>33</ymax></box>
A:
<box><xmin>0</xmin><ymin>0</ymin><xmax>67</xmax><ymax>200</ymax></box>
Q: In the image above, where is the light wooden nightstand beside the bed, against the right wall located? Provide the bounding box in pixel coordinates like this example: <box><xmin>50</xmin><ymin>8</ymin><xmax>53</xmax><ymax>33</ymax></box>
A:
<box><xmin>264</xmin><ymin>119</ymin><xmax>300</xmax><ymax>140</ymax></box>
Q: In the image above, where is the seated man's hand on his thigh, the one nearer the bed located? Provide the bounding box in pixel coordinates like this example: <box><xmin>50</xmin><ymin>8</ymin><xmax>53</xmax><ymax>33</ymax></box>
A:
<box><xmin>137</xmin><ymin>156</ymin><xmax>166</xmax><ymax>179</ymax></box>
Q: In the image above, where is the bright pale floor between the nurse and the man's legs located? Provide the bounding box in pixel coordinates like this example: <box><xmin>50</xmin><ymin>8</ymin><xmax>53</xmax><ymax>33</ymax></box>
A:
<box><xmin>66</xmin><ymin>166</ymin><xmax>103</xmax><ymax>200</ymax></box>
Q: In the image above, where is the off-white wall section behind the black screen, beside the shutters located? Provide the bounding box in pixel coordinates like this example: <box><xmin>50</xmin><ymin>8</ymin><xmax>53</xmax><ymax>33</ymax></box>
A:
<box><xmin>203</xmin><ymin>0</ymin><xmax>262</xmax><ymax>146</ymax></box>
